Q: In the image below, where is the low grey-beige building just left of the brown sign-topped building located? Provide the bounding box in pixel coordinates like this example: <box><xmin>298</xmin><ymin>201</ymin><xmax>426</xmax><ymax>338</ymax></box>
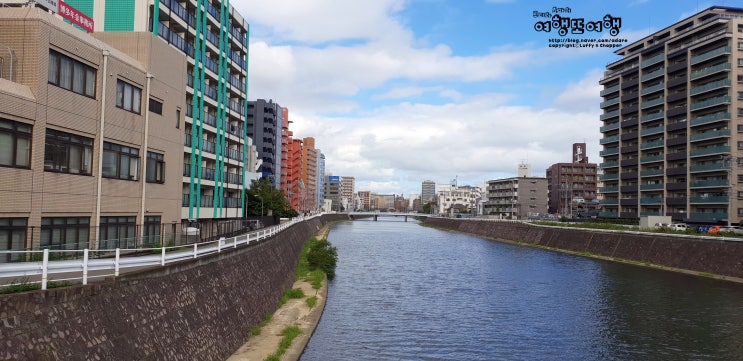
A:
<box><xmin>483</xmin><ymin>163</ymin><xmax>548</xmax><ymax>219</ymax></box>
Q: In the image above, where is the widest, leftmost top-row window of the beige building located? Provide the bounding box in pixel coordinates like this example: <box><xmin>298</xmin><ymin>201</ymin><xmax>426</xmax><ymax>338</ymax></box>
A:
<box><xmin>48</xmin><ymin>50</ymin><xmax>97</xmax><ymax>98</ymax></box>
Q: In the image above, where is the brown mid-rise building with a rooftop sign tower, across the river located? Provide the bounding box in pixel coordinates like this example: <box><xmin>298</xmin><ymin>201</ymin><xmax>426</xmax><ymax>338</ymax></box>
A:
<box><xmin>547</xmin><ymin>143</ymin><xmax>598</xmax><ymax>217</ymax></box>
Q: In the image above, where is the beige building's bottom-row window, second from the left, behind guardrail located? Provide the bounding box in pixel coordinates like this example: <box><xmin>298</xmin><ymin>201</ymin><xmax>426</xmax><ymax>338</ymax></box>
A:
<box><xmin>41</xmin><ymin>217</ymin><xmax>90</xmax><ymax>249</ymax></box>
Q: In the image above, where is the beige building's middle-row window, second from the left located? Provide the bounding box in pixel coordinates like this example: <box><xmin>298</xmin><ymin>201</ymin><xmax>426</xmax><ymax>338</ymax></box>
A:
<box><xmin>44</xmin><ymin>129</ymin><xmax>93</xmax><ymax>175</ymax></box>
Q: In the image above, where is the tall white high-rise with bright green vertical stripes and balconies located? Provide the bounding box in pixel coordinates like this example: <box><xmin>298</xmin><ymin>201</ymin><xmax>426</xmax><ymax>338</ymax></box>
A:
<box><xmin>65</xmin><ymin>0</ymin><xmax>253</xmax><ymax>218</ymax></box>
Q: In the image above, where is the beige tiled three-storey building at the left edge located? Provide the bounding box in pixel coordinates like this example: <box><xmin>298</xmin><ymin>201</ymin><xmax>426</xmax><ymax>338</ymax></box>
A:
<box><xmin>0</xmin><ymin>7</ymin><xmax>187</xmax><ymax>250</ymax></box>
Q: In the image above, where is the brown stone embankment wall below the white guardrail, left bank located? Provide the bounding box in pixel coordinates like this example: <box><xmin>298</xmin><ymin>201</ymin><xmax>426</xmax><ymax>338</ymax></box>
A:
<box><xmin>0</xmin><ymin>215</ymin><xmax>347</xmax><ymax>361</ymax></box>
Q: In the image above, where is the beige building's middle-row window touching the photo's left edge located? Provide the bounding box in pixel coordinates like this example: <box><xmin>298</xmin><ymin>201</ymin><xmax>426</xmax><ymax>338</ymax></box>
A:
<box><xmin>0</xmin><ymin>118</ymin><xmax>31</xmax><ymax>168</ymax></box>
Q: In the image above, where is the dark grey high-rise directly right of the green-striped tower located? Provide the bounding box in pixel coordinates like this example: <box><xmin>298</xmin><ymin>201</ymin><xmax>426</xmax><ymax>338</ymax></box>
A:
<box><xmin>247</xmin><ymin>99</ymin><xmax>284</xmax><ymax>189</ymax></box>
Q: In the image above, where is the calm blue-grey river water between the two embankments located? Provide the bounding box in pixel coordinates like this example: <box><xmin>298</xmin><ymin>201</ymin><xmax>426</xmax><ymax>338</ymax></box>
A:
<box><xmin>301</xmin><ymin>217</ymin><xmax>743</xmax><ymax>361</ymax></box>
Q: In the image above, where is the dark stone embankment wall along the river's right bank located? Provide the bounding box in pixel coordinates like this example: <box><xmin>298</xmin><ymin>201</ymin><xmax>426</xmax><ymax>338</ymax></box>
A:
<box><xmin>425</xmin><ymin>218</ymin><xmax>743</xmax><ymax>278</ymax></box>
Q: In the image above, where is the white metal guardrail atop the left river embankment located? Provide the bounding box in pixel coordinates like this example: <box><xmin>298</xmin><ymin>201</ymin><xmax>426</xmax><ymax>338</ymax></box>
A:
<box><xmin>0</xmin><ymin>217</ymin><xmax>312</xmax><ymax>290</ymax></box>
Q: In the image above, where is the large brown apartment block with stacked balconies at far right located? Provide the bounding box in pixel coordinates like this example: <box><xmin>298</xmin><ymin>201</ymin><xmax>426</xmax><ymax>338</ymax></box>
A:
<box><xmin>599</xmin><ymin>6</ymin><xmax>743</xmax><ymax>224</ymax></box>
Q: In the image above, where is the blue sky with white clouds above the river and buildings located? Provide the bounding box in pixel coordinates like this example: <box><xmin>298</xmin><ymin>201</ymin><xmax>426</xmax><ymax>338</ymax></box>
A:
<box><xmin>231</xmin><ymin>0</ymin><xmax>740</xmax><ymax>196</ymax></box>
